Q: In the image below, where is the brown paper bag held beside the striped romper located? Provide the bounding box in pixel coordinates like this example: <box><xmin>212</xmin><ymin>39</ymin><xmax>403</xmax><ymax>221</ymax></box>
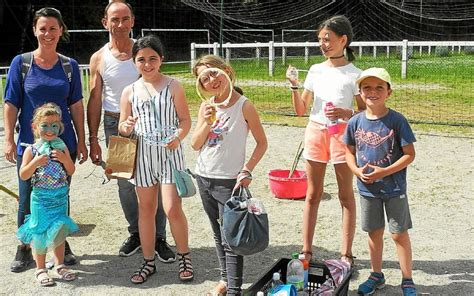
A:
<box><xmin>105</xmin><ymin>136</ymin><xmax>137</xmax><ymax>180</ymax></box>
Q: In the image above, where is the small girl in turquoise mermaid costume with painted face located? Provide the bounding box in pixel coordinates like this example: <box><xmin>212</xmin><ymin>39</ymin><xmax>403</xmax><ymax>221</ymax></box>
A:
<box><xmin>17</xmin><ymin>103</ymin><xmax>78</xmax><ymax>286</ymax></box>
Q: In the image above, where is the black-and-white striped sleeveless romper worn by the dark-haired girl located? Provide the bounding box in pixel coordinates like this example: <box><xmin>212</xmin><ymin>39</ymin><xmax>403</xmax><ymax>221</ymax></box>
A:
<box><xmin>130</xmin><ymin>79</ymin><xmax>185</xmax><ymax>187</ymax></box>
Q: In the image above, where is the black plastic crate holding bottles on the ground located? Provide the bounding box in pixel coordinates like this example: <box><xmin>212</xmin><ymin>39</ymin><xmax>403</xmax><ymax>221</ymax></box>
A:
<box><xmin>244</xmin><ymin>258</ymin><xmax>353</xmax><ymax>296</ymax></box>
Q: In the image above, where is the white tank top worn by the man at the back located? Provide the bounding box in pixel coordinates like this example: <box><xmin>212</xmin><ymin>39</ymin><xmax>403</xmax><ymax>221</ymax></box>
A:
<box><xmin>100</xmin><ymin>43</ymin><xmax>139</xmax><ymax>113</ymax></box>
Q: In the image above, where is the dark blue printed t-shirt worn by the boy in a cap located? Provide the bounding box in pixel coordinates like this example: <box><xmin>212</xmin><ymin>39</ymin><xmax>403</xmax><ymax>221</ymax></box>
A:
<box><xmin>344</xmin><ymin>109</ymin><xmax>416</xmax><ymax>197</ymax></box>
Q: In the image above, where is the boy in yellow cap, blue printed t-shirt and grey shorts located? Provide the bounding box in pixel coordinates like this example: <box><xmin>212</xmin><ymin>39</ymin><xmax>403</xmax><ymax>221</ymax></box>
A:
<box><xmin>344</xmin><ymin>68</ymin><xmax>416</xmax><ymax>295</ymax></box>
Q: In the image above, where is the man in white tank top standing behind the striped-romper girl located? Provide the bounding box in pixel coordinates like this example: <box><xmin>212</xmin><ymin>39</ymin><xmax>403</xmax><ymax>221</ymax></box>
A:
<box><xmin>87</xmin><ymin>1</ymin><xmax>175</xmax><ymax>263</ymax></box>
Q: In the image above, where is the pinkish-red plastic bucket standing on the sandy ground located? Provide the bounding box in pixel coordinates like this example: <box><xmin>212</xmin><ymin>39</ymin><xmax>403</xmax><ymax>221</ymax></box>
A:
<box><xmin>268</xmin><ymin>170</ymin><xmax>308</xmax><ymax>199</ymax></box>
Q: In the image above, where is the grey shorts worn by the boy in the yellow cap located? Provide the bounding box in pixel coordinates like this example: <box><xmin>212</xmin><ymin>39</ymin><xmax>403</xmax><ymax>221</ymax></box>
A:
<box><xmin>360</xmin><ymin>194</ymin><xmax>412</xmax><ymax>233</ymax></box>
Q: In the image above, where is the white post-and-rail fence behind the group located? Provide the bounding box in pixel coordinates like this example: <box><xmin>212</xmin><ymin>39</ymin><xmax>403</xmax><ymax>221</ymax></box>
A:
<box><xmin>191</xmin><ymin>40</ymin><xmax>474</xmax><ymax>79</ymax></box>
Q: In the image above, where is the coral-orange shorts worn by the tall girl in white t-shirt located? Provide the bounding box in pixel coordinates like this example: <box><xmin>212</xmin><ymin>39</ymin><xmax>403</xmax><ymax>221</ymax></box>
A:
<box><xmin>303</xmin><ymin>120</ymin><xmax>347</xmax><ymax>164</ymax></box>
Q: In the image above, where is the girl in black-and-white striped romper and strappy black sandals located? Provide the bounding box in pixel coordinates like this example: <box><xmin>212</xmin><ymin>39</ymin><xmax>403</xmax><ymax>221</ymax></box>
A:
<box><xmin>118</xmin><ymin>35</ymin><xmax>194</xmax><ymax>284</ymax></box>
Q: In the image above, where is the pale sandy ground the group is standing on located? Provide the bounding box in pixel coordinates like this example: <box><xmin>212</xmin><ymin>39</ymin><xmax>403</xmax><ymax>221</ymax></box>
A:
<box><xmin>0</xmin><ymin>125</ymin><xmax>474</xmax><ymax>295</ymax></box>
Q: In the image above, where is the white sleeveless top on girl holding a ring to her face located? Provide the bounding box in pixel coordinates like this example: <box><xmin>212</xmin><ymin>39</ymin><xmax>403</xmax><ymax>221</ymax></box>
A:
<box><xmin>196</xmin><ymin>96</ymin><xmax>249</xmax><ymax>179</ymax></box>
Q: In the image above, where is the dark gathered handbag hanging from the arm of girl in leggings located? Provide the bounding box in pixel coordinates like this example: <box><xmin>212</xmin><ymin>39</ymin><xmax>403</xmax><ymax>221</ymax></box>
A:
<box><xmin>222</xmin><ymin>187</ymin><xmax>270</xmax><ymax>256</ymax></box>
